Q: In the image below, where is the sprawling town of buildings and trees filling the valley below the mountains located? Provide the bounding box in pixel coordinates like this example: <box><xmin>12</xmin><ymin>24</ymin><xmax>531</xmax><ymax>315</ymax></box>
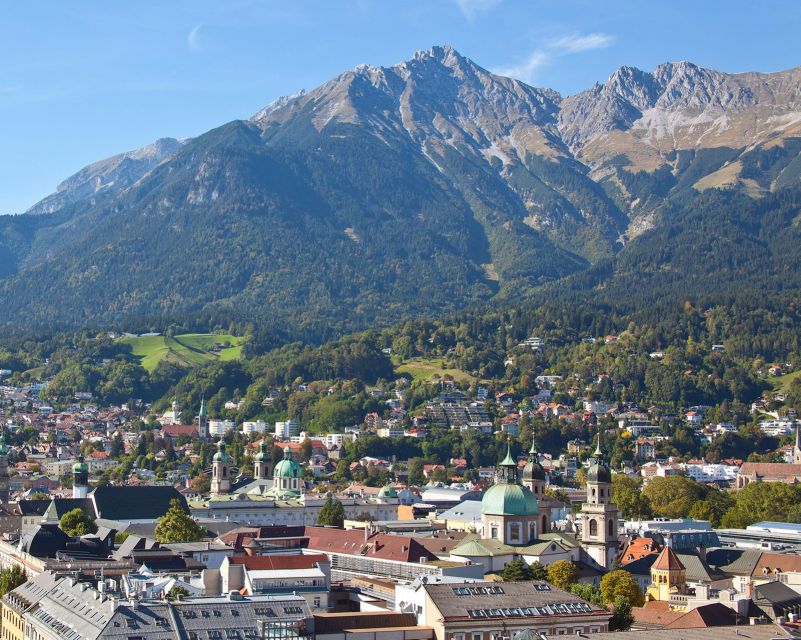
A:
<box><xmin>0</xmin><ymin>336</ymin><xmax>801</xmax><ymax>640</ymax></box>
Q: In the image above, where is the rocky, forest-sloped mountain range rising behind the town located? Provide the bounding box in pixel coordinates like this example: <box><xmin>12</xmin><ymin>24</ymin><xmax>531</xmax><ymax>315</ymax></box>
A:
<box><xmin>0</xmin><ymin>46</ymin><xmax>801</xmax><ymax>339</ymax></box>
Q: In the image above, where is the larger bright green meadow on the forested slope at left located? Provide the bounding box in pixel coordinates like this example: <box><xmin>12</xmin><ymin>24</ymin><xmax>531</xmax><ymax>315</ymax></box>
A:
<box><xmin>120</xmin><ymin>333</ymin><xmax>243</xmax><ymax>371</ymax></box>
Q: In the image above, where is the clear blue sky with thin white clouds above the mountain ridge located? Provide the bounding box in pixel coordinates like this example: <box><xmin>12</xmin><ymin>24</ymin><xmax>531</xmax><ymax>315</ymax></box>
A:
<box><xmin>0</xmin><ymin>0</ymin><xmax>801</xmax><ymax>213</ymax></box>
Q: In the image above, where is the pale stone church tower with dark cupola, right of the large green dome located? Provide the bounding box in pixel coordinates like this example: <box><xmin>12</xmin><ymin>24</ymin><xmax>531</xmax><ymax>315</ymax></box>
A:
<box><xmin>581</xmin><ymin>431</ymin><xmax>618</xmax><ymax>569</ymax></box>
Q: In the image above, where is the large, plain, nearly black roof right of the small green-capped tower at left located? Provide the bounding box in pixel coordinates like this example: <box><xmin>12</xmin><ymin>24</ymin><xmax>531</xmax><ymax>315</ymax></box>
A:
<box><xmin>92</xmin><ymin>485</ymin><xmax>189</xmax><ymax>520</ymax></box>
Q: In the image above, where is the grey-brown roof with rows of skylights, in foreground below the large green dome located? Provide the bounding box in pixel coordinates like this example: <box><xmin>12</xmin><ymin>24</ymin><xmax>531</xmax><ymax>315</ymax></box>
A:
<box><xmin>423</xmin><ymin>581</ymin><xmax>611</xmax><ymax>620</ymax></box>
